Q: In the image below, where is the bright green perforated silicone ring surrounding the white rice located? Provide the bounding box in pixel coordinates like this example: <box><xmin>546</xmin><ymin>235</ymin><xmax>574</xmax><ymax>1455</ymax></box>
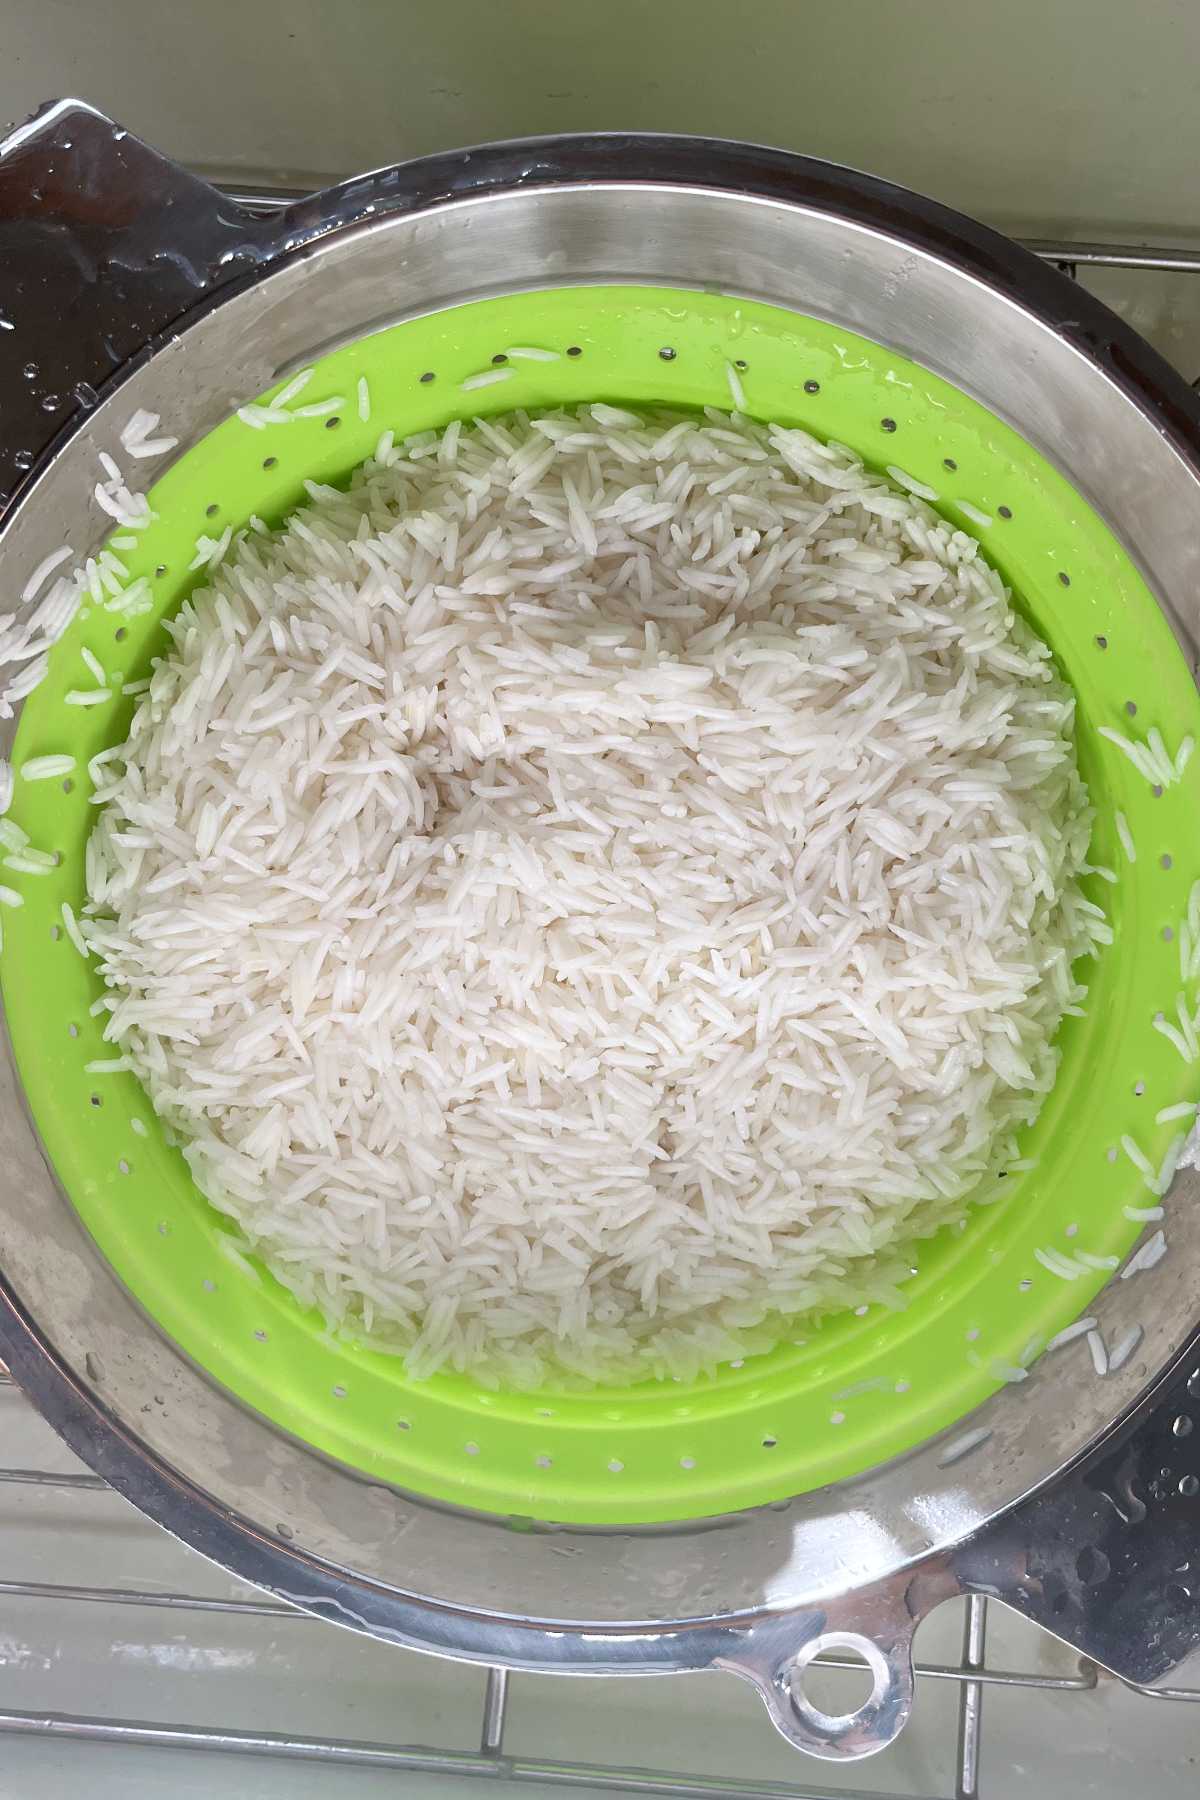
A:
<box><xmin>0</xmin><ymin>284</ymin><xmax>1200</xmax><ymax>1525</ymax></box>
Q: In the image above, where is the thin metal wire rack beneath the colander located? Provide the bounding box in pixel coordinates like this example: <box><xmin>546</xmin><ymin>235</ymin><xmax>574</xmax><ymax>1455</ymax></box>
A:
<box><xmin>0</xmin><ymin>217</ymin><xmax>1200</xmax><ymax>1800</ymax></box>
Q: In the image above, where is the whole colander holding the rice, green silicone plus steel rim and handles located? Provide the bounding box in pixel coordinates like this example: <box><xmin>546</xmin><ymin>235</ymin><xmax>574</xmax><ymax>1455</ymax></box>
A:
<box><xmin>0</xmin><ymin>106</ymin><xmax>1200</xmax><ymax>1757</ymax></box>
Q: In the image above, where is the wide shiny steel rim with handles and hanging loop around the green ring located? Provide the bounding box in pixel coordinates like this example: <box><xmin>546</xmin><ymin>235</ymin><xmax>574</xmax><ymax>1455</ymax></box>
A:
<box><xmin>0</xmin><ymin>103</ymin><xmax>1200</xmax><ymax>1759</ymax></box>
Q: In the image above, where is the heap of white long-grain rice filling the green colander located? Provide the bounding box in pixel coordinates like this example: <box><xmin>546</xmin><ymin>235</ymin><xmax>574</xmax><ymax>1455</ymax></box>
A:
<box><xmin>81</xmin><ymin>405</ymin><xmax>1106</xmax><ymax>1386</ymax></box>
